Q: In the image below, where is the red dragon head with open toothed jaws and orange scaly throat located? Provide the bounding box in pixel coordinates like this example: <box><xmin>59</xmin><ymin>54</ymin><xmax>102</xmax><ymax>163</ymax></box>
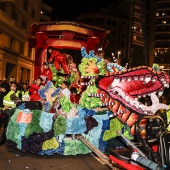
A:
<box><xmin>82</xmin><ymin>49</ymin><xmax>169</xmax><ymax>135</ymax></box>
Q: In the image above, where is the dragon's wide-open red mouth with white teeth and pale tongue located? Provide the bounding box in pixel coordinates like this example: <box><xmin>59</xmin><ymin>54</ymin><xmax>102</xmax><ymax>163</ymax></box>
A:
<box><xmin>96</xmin><ymin>66</ymin><xmax>169</xmax><ymax>115</ymax></box>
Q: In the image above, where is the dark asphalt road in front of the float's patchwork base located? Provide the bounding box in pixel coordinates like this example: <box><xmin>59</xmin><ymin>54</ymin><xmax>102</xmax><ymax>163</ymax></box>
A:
<box><xmin>0</xmin><ymin>144</ymin><xmax>111</xmax><ymax>170</ymax></box>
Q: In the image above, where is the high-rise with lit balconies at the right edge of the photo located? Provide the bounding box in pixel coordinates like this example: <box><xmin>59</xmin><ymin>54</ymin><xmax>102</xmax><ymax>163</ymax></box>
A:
<box><xmin>154</xmin><ymin>0</ymin><xmax>170</xmax><ymax>74</ymax></box>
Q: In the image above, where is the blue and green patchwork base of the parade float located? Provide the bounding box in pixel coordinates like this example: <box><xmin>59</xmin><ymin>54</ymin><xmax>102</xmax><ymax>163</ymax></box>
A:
<box><xmin>6</xmin><ymin>108</ymin><xmax>126</xmax><ymax>155</ymax></box>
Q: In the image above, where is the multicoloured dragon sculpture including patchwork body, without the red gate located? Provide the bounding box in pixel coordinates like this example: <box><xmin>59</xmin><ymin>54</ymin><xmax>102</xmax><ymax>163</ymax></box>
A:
<box><xmin>6</xmin><ymin>47</ymin><xmax>169</xmax><ymax>155</ymax></box>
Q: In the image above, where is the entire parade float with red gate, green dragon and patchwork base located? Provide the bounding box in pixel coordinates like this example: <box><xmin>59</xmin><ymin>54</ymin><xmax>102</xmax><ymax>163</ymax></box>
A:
<box><xmin>6</xmin><ymin>21</ymin><xmax>169</xmax><ymax>169</ymax></box>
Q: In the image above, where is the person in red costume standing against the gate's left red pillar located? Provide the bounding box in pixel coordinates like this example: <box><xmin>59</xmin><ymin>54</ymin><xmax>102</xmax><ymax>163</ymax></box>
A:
<box><xmin>40</xmin><ymin>62</ymin><xmax>53</xmax><ymax>86</ymax></box>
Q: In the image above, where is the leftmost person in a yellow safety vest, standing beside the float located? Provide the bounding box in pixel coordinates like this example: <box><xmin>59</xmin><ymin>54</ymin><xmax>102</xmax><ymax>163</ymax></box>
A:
<box><xmin>3</xmin><ymin>82</ymin><xmax>21</xmax><ymax>109</ymax></box>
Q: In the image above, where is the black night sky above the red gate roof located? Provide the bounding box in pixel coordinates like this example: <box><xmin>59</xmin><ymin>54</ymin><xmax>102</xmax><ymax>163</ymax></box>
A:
<box><xmin>43</xmin><ymin>0</ymin><xmax>116</xmax><ymax>21</ymax></box>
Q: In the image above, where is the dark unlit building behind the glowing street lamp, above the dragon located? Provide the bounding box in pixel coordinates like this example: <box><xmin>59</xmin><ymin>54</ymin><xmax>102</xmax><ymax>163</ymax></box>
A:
<box><xmin>75</xmin><ymin>4</ymin><xmax>129</xmax><ymax>62</ymax></box>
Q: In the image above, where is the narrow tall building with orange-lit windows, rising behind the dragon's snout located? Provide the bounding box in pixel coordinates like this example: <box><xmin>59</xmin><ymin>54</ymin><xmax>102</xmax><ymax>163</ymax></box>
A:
<box><xmin>128</xmin><ymin>0</ymin><xmax>145</xmax><ymax>67</ymax></box>
